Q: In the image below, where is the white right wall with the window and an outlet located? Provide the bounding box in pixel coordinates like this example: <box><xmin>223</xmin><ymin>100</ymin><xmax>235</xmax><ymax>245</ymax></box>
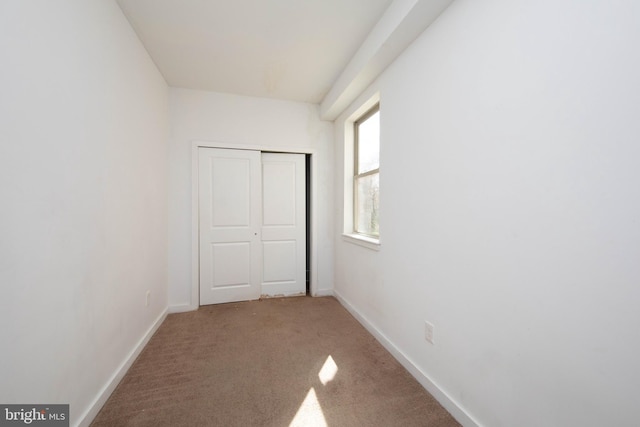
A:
<box><xmin>335</xmin><ymin>0</ymin><xmax>640</xmax><ymax>426</ymax></box>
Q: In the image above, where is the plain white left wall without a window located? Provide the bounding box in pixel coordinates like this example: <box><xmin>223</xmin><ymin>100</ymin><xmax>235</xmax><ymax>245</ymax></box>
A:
<box><xmin>0</xmin><ymin>0</ymin><xmax>168</xmax><ymax>425</ymax></box>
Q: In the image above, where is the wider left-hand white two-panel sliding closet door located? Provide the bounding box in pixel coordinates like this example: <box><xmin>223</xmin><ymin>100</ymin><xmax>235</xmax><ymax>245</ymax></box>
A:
<box><xmin>198</xmin><ymin>148</ymin><xmax>262</xmax><ymax>305</ymax></box>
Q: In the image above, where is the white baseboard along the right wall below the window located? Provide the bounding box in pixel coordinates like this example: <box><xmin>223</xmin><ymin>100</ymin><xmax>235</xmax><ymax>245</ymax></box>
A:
<box><xmin>333</xmin><ymin>290</ymin><xmax>480</xmax><ymax>427</ymax></box>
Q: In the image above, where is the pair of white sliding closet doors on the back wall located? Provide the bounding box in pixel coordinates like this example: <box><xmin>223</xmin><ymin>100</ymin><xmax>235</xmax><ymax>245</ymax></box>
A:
<box><xmin>198</xmin><ymin>148</ymin><xmax>306</xmax><ymax>305</ymax></box>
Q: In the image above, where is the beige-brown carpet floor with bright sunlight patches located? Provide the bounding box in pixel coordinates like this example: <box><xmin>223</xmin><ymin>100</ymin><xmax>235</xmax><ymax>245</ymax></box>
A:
<box><xmin>92</xmin><ymin>297</ymin><xmax>459</xmax><ymax>427</ymax></box>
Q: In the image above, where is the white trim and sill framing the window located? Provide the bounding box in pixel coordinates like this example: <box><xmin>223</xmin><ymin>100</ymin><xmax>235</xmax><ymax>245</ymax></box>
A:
<box><xmin>342</xmin><ymin>93</ymin><xmax>382</xmax><ymax>251</ymax></box>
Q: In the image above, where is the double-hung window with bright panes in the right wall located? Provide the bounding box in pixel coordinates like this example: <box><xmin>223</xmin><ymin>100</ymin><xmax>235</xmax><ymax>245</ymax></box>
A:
<box><xmin>353</xmin><ymin>104</ymin><xmax>380</xmax><ymax>239</ymax></box>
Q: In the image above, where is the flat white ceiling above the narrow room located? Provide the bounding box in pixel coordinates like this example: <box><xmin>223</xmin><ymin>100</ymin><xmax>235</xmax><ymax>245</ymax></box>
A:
<box><xmin>117</xmin><ymin>0</ymin><xmax>392</xmax><ymax>103</ymax></box>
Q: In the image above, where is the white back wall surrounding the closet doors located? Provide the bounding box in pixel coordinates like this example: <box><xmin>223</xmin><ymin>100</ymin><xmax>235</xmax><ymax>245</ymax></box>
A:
<box><xmin>169</xmin><ymin>88</ymin><xmax>334</xmax><ymax>311</ymax></box>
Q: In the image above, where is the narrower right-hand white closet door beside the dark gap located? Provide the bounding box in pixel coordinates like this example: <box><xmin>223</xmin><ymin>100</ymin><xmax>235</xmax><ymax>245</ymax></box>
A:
<box><xmin>262</xmin><ymin>153</ymin><xmax>306</xmax><ymax>296</ymax></box>
